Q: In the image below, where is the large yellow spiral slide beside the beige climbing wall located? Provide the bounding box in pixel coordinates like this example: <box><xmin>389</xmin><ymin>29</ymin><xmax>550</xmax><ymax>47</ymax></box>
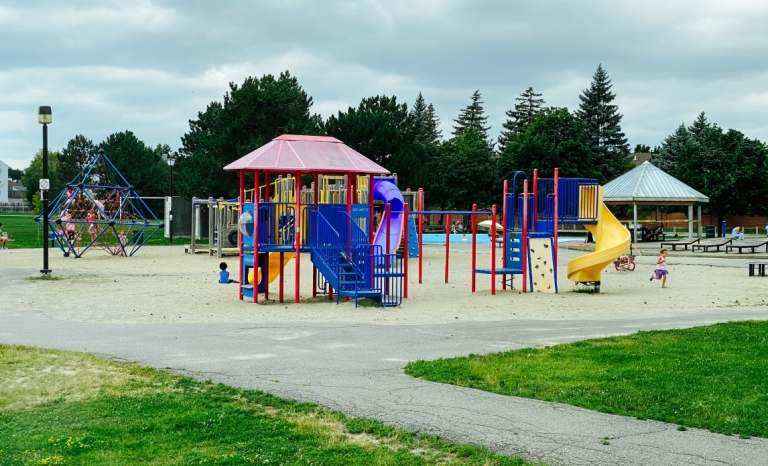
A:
<box><xmin>568</xmin><ymin>186</ymin><xmax>631</xmax><ymax>282</ymax></box>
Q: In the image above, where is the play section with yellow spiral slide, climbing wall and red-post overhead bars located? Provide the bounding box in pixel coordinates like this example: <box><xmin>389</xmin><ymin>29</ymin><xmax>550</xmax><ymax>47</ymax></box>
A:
<box><xmin>412</xmin><ymin>169</ymin><xmax>631</xmax><ymax>295</ymax></box>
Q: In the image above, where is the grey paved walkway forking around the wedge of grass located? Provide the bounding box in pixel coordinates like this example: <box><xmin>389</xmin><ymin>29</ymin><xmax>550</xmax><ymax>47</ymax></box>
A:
<box><xmin>0</xmin><ymin>269</ymin><xmax>768</xmax><ymax>465</ymax></box>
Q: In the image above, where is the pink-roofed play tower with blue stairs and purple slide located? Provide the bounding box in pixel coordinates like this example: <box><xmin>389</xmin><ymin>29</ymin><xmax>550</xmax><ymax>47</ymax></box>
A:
<box><xmin>225</xmin><ymin>135</ymin><xmax>416</xmax><ymax>306</ymax></box>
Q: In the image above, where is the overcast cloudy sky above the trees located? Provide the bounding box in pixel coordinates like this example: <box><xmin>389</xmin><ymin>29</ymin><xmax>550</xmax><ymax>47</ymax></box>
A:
<box><xmin>0</xmin><ymin>0</ymin><xmax>768</xmax><ymax>169</ymax></box>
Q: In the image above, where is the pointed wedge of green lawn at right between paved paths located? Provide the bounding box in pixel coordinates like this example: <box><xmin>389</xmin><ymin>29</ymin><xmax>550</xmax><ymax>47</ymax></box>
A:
<box><xmin>405</xmin><ymin>321</ymin><xmax>768</xmax><ymax>437</ymax></box>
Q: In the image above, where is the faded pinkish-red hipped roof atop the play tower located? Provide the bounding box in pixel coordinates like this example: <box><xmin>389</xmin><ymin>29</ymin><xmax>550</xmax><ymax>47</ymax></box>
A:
<box><xmin>224</xmin><ymin>134</ymin><xmax>389</xmax><ymax>175</ymax></box>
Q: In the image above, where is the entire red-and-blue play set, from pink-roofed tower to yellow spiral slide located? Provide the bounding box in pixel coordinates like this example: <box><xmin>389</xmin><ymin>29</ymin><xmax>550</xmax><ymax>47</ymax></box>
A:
<box><xmin>225</xmin><ymin>135</ymin><xmax>630</xmax><ymax>306</ymax></box>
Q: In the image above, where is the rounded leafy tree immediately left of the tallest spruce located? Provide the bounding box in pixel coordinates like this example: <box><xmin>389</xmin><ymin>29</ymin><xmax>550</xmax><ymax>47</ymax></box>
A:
<box><xmin>499</xmin><ymin>108</ymin><xmax>598</xmax><ymax>179</ymax></box>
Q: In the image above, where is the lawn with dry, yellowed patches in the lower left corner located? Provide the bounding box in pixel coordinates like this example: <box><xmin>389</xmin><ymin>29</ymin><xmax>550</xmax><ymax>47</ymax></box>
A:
<box><xmin>0</xmin><ymin>345</ymin><xmax>531</xmax><ymax>465</ymax></box>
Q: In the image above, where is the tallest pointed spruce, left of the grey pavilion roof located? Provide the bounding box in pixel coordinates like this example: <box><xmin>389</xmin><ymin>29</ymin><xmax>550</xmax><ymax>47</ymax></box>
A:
<box><xmin>576</xmin><ymin>65</ymin><xmax>631</xmax><ymax>182</ymax></box>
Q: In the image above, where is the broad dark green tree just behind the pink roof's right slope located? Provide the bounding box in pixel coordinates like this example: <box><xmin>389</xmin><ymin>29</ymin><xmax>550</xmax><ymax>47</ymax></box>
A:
<box><xmin>325</xmin><ymin>95</ymin><xmax>426</xmax><ymax>187</ymax></box>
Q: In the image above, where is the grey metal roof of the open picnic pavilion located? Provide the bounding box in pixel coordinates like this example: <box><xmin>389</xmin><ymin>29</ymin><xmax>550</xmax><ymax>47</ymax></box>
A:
<box><xmin>603</xmin><ymin>162</ymin><xmax>709</xmax><ymax>205</ymax></box>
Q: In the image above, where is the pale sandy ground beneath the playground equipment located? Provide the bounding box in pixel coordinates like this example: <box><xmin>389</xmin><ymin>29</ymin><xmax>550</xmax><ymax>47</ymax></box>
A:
<box><xmin>0</xmin><ymin>245</ymin><xmax>768</xmax><ymax>324</ymax></box>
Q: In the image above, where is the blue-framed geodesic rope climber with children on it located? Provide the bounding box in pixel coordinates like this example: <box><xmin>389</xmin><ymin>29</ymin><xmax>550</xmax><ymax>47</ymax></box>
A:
<box><xmin>35</xmin><ymin>150</ymin><xmax>164</xmax><ymax>258</ymax></box>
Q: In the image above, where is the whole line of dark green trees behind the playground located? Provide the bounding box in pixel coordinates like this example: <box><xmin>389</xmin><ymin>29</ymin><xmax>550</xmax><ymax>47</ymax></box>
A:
<box><xmin>16</xmin><ymin>65</ymin><xmax>768</xmax><ymax>224</ymax></box>
